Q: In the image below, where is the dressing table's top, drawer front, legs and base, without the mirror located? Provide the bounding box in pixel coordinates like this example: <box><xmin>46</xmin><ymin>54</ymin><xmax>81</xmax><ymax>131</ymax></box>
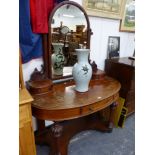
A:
<box><xmin>32</xmin><ymin>76</ymin><xmax>121</xmax><ymax>155</ymax></box>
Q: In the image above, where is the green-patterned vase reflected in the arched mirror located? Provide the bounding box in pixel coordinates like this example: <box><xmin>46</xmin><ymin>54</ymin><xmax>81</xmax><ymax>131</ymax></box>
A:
<box><xmin>52</xmin><ymin>43</ymin><xmax>65</xmax><ymax>75</ymax></box>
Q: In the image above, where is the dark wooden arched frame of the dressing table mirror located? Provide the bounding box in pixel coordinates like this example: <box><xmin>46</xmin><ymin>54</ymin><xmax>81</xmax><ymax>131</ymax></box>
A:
<box><xmin>46</xmin><ymin>1</ymin><xmax>92</xmax><ymax>81</ymax></box>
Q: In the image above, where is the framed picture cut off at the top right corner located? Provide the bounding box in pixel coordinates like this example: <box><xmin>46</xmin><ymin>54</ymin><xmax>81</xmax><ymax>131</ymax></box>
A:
<box><xmin>120</xmin><ymin>0</ymin><xmax>135</xmax><ymax>32</ymax></box>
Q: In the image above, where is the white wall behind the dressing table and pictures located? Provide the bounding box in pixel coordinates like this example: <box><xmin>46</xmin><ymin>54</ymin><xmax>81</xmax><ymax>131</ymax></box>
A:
<box><xmin>23</xmin><ymin>0</ymin><xmax>135</xmax><ymax>129</ymax></box>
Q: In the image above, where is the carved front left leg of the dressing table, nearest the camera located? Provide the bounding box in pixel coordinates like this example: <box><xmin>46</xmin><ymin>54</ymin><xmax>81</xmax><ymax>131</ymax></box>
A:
<box><xmin>50</xmin><ymin>123</ymin><xmax>68</xmax><ymax>155</ymax></box>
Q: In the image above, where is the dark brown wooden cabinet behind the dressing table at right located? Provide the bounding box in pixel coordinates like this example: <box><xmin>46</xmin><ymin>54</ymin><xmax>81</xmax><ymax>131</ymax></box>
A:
<box><xmin>105</xmin><ymin>57</ymin><xmax>135</xmax><ymax>115</ymax></box>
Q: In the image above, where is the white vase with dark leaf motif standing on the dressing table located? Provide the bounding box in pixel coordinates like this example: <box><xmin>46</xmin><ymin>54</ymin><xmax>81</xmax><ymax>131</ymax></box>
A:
<box><xmin>72</xmin><ymin>49</ymin><xmax>92</xmax><ymax>92</ymax></box>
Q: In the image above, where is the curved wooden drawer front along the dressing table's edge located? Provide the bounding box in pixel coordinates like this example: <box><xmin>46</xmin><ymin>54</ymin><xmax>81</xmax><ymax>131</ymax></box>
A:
<box><xmin>32</xmin><ymin>93</ymin><xmax>119</xmax><ymax>121</ymax></box>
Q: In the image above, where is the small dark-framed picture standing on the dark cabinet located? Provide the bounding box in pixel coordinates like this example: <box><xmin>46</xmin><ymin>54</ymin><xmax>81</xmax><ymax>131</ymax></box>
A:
<box><xmin>107</xmin><ymin>36</ymin><xmax>120</xmax><ymax>59</ymax></box>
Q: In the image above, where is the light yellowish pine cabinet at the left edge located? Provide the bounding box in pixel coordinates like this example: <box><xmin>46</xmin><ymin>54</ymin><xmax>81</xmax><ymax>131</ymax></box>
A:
<box><xmin>19</xmin><ymin>88</ymin><xmax>36</xmax><ymax>155</ymax></box>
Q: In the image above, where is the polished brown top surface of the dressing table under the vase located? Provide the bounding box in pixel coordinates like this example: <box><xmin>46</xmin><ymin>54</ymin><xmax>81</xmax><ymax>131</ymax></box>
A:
<box><xmin>32</xmin><ymin>77</ymin><xmax>120</xmax><ymax>110</ymax></box>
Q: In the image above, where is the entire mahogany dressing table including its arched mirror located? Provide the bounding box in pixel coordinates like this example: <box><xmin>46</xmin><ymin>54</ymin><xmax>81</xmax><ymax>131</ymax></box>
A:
<box><xmin>27</xmin><ymin>1</ymin><xmax>121</xmax><ymax>155</ymax></box>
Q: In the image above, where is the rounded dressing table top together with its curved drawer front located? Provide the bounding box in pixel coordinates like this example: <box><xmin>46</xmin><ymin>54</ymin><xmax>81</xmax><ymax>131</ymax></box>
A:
<box><xmin>32</xmin><ymin>76</ymin><xmax>121</xmax><ymax>120</ymax></box>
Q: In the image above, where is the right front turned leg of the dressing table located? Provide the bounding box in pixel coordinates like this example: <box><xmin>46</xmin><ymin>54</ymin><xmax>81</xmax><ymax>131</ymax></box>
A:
<box><xmin>108</xmin><ymin>102</ymin><xmax>118</xmax><ymax>132</ymax></box>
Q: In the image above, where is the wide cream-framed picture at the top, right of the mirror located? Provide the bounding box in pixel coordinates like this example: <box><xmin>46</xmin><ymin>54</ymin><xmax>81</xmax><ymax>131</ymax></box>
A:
<box><xmin>83</xmin><ymin>0</ymin><xmax>125</xmax><ymax>19</ymax></box>
